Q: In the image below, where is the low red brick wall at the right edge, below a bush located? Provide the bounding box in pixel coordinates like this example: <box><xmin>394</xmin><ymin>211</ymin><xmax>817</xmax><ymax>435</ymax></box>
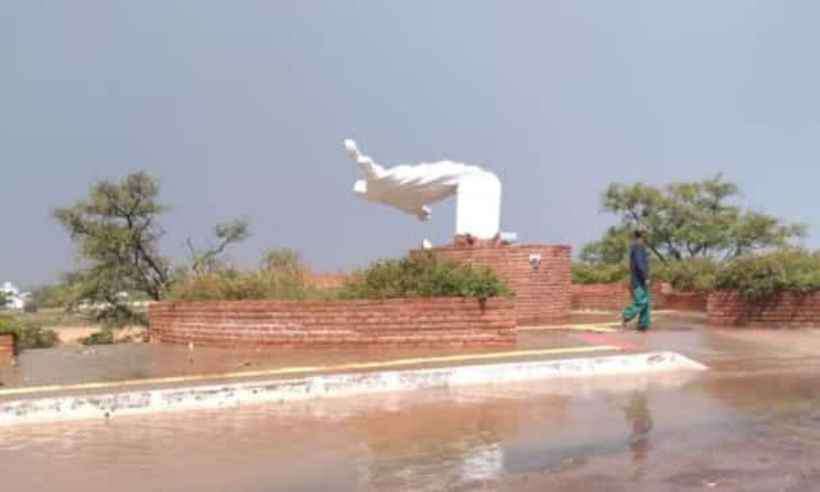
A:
<box><xmin>707</xmin><ymin>291</ymin><xmax>820</xmax><ymax>328</ymax></box>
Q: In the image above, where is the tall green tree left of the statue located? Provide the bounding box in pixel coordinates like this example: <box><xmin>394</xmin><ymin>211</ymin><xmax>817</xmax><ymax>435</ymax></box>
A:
<box><xmin>54</xmin><ymin>172</ymin><xmax>171</xmax><ymax>319</ymax></box>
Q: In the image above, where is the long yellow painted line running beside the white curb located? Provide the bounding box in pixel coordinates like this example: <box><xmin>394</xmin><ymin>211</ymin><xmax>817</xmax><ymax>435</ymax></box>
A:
<box><xmin>0</xmin><ymin>345</ymin><xmax>621</xmax><ymax>396</ymax></box>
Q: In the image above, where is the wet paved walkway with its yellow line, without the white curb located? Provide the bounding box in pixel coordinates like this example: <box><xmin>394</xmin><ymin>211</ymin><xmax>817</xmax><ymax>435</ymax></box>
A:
<box><xmin>0</xmin><ymin>313</ymin><xmax>699</xmax><ymax>400</ymax></box>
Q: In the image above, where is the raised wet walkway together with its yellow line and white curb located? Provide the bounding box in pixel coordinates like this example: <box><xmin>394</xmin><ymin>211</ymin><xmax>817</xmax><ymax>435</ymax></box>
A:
<box><xmin>0</xmin><ymin>313</ymin><xmax>716</xmax><ymax>423</ymax></box>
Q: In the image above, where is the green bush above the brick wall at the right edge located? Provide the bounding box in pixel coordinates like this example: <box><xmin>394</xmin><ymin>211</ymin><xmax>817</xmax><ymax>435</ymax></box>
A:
<box><xmin>715</xmin><ymin>249</ymin><xmax>820</xmax><ymax>300</ymax></box>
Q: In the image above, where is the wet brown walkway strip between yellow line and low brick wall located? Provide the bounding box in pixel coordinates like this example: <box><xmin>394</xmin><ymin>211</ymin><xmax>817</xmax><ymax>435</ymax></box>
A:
<box><xmin>0</xmin><ymin>314</ymin><xmax>628</xmax><ymax>398</ymax></box>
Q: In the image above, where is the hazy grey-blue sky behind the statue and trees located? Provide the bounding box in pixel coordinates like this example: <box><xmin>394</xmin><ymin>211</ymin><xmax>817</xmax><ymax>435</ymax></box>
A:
<box><xmin>0</xmin><ymin>0</ymin><xmax>820</xmax><ymax>285</ymax></box>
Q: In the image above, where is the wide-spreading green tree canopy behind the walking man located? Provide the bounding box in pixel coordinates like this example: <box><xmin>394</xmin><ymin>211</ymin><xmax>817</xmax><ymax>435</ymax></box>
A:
<box><xmin>580</xmin><ymin>175</ymin><xmax>806</xmax><ymax>264</ymax></box>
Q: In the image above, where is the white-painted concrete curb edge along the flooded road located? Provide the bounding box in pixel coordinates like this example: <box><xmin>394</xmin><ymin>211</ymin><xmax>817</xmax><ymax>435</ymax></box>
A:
<box><xmin>0</xmin><ymin>352</ymin><xmax>707</xmax><ymax>425</ymax></box>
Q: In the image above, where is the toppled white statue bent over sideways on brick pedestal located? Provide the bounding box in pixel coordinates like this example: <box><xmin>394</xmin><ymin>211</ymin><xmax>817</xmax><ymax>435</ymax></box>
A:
<box><xmin>344</xmin><ymin>140</ymin><xmax>501</xmax><ymax>239</ymax></box>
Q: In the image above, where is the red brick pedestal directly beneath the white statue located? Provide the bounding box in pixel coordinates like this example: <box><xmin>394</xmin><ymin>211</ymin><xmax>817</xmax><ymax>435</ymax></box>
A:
<box><xmin>433</xmin><ymin>243</ymin><xmax>572</xmax><ymax>325</ymax></box>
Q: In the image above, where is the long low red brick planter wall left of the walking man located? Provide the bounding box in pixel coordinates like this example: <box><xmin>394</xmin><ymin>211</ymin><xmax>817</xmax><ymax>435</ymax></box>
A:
<box><xmin>148</xmin><ymin>298</ymin><xmax>516</xmax><ymax>347</ymax></box>
